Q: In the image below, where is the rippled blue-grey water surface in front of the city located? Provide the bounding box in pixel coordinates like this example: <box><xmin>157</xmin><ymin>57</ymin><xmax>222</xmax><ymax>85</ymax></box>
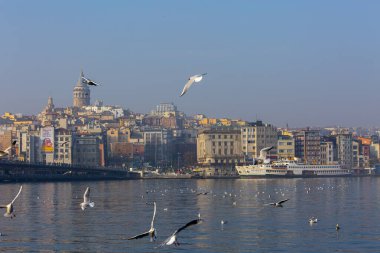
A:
<box><xmin>0</xmin><ymin>177</ymin><xmax>380</xmax><ymax>252</ymax></box>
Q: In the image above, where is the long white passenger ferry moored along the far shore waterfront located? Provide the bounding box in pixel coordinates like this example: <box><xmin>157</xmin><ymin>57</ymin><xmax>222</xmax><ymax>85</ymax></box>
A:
<box><xmin>236</xmin><ymin>160</ymin><xmax>352</xmax><ymax>177</ymax></box>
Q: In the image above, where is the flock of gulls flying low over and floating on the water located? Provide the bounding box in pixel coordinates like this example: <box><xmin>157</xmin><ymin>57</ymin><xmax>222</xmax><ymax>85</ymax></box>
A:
<box><xmin>0</xmin><ymin>182</ymin><xmax>340</xmax><ymax>247</ymax></box>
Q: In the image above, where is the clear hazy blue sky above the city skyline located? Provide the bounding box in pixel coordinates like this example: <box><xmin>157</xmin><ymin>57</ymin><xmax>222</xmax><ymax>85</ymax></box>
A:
<box><xmin>0</xmin><ymin>0</ymin><xmax>380</xmax><ymax>127</ymax></box>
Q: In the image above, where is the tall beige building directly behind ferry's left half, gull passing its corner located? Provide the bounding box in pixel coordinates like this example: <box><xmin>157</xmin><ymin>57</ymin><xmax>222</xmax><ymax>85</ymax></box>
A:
<box><xmin>240</xmin><ymin>121</ymin><xmax>277</xmax><ymax>158</ymax></box>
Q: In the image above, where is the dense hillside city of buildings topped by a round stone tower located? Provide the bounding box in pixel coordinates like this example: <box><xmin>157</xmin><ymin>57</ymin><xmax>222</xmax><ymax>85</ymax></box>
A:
<box><xmin>0</xmin><ymin>72</ymin><xmax>380</xmax><ymax>171</ymax></box>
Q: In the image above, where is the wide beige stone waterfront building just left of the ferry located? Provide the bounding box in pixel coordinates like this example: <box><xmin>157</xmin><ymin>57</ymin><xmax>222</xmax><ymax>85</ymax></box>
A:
<box><xmin>197</xmin><ymin>128</ymin><xmax>244</xmax><ymax>166</ymax></box>
